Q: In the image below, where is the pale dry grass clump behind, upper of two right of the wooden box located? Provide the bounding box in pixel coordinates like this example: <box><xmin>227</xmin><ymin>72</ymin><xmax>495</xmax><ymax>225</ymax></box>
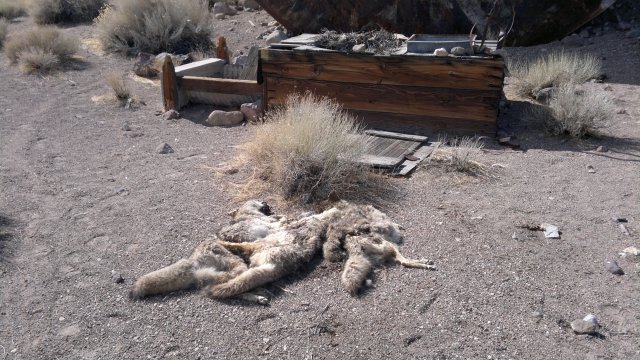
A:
<box><xmin>508</xmin><ymin>51</ymin><xmax>601</xmax><ymax>97</ymax></box>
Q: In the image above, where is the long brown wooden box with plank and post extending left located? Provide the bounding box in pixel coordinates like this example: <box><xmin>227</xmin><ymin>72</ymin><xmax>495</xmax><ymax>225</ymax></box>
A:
<box><xmin>163</xmin><ymin>34</ymin><xmax>505</xmax><ymax>136</ymax></box>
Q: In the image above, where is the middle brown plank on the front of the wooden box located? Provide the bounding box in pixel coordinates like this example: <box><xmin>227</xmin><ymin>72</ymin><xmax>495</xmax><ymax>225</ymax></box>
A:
<box><xmin>266</xmin><ymin>76</ymin><xmax>501</xmax><ymax>122</ymax></box>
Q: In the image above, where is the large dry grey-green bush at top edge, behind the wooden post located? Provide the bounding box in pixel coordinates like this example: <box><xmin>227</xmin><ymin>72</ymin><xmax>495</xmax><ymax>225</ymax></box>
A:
<box><xmin>96</xmin><ymin>0</ymin><xmax>212</xmax><ymax>55</ymax></box>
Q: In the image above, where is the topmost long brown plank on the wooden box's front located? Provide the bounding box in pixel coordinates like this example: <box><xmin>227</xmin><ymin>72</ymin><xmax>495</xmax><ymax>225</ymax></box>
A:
<box><xmin>261</xmin><ymin>49</ymin><xmax>504</xmax><ymax>90</ymax></box>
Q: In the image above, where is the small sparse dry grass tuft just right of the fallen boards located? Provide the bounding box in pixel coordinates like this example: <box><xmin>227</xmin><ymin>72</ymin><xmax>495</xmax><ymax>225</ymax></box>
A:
<box><xmin>431</xmin><ymin>137</ymin><xmax>493</xmax><ymax>177</ymax></box>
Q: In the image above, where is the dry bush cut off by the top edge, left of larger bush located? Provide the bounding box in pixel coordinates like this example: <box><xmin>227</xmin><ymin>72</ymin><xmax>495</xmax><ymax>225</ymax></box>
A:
<box><xmin>29</xmin><ymin>0</ymin><xmax>107</xmax><ymax>24</ymax></box>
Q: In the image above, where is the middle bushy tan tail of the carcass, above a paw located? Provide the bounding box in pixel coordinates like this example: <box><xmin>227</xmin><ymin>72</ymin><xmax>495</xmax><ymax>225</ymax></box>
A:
<box><xmin>205</xmin><ymin>264</ymin><xmax>284</xmax><ymax>299</ymax></box>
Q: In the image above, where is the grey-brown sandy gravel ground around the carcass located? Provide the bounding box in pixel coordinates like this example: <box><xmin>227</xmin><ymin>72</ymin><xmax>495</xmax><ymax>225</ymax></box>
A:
<box><xmin>0</xmin><ymin>3</ymin><xmax>640</xmax><ymax>360</ymax></box>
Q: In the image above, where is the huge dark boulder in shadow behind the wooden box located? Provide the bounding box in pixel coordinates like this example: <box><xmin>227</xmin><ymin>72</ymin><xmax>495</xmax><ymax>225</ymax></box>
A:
<box><xmin>256</xmin><ymin>0</ymin><xmax>615</xmax><ymax>45</ymax></box>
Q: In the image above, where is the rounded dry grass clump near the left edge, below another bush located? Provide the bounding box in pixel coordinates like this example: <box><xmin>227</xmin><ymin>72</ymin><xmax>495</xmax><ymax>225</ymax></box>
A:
<box><xmin>4</xmin><ymin>26</ymin><xmax>79</xmax><ymax>73</ymax></box>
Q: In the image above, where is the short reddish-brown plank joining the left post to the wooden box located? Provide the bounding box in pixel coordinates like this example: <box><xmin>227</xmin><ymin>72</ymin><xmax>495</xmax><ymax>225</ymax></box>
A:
<box><xmin>178</xmin><ymin>76</ymin><xmax>262</xmax><ymax>96</ymax></box>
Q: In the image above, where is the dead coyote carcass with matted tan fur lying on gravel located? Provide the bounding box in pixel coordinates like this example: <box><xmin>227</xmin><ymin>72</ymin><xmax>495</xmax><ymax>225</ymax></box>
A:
<box><xmin>130</xmin><ymin>200</ymin><xmax>434</xmax><ymax>304</ymax></box>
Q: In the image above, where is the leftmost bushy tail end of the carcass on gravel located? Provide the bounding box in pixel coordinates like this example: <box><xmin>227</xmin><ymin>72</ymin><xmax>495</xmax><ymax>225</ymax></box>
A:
<box><xmin>129</xmin><ymin>259</ymin><xmax>196</xmax><ymax>299</ymax></box>
